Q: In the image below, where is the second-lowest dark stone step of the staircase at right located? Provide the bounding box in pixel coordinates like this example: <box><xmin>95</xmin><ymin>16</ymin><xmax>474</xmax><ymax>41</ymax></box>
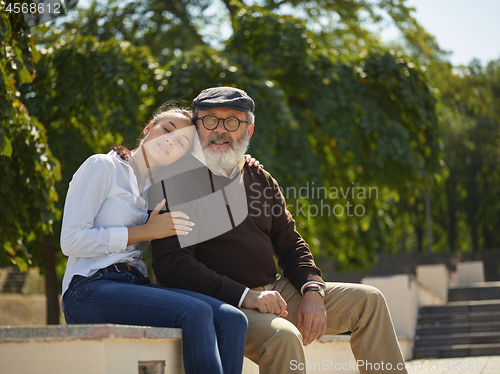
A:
<box><xmin>415</xmin><ymin>332</ymin><xmax>500</xmax><ymax>348</ymax></box>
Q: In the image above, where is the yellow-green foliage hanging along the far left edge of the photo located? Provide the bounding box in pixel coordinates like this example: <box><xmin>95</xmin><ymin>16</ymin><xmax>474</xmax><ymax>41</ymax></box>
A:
<box><xmin>0</xmin><ymin>3</ymin><xmax>60</xmax><ymax>270</ymax></box>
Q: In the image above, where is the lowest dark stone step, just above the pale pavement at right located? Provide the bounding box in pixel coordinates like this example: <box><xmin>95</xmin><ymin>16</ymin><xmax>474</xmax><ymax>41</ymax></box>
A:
<box><xmin>413</xmin><ymin>343</ymin><xmax>500</xmax><ymax>359</ymax></box>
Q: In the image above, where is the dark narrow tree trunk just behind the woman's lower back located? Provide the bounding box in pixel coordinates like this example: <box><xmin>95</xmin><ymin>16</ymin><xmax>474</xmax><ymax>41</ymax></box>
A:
<box><xmin>43</xmin><ymin>235</ymin><xmax>60</xmax><ymax>325</ymax></box>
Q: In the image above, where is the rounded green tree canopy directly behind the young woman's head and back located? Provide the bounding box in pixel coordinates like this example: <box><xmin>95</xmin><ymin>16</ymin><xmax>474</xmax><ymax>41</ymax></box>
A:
<box><xmin>21</xmin><ymin>27</ymin><xmax>158</xmax><ymax>319</ymax></box>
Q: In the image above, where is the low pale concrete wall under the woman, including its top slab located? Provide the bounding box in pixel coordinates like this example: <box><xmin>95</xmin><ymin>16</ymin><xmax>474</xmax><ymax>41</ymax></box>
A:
<box><xmin>0</xmin><ymin>325</ymin><xmax>184</xmax><ymax>374</ymax></box>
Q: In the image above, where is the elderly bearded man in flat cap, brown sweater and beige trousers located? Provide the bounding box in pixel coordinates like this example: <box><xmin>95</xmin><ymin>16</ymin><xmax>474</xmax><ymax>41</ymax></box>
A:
<box><xmin>150</xmin><ymin>87</ymin><xmax>406</xmax><ymax>374</ymax></box>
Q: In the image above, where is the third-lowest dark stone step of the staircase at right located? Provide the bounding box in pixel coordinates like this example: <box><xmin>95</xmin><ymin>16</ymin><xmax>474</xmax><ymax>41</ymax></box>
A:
<box><xmin>417</xmin><ymin>320</ymin><xmax>500</xmax><ymax>336</ymax></box>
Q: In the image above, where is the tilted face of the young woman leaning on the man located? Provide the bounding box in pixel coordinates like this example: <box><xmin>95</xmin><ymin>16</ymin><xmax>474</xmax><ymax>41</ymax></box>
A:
<box><xmin>142</xmin><ymin>113</ymin><xmax>195</xmax><ymax>168</ymax></box>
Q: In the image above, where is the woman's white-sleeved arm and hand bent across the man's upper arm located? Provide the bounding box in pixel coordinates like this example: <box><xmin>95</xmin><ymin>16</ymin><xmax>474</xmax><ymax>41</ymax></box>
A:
<box><xmin>61</xmin><ymin>155</ymin><xmax>194</xmax><ymax>257</ymax></box>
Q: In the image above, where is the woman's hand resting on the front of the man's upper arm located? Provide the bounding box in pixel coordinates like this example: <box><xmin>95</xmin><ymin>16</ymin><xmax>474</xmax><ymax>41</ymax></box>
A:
<box><xmin>145</xmin><ymin>200</ymin><xmax>194</xmax><ymax>240</ymax></box>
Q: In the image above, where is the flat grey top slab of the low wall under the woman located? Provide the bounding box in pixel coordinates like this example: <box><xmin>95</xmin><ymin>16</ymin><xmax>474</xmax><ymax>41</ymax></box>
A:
<box><xmin>0</xmin><ymin>324</ymin><xmax>182</xmax><ymax>343</ymax></box>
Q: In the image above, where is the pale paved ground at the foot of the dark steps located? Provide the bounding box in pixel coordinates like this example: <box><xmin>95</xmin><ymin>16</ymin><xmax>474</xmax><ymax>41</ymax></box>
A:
<box><xmin>406</xmin><ymin>352</ymin><xmax>500</xmax><ymax>374</ymax></box>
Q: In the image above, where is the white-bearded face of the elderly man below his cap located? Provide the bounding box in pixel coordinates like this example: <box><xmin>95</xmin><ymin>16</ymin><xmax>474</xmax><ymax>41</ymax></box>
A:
<box><xmin>197</xmin><ymin>108</ymin><xmax>254</xmax><ymax>165</ymax></box>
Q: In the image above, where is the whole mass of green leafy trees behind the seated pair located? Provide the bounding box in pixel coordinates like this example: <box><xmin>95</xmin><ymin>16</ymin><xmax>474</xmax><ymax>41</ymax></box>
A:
<box><xmin>0</xmin><ymin>0</ymin><xmax>500</xmax><ymax>323</ymax></box>
